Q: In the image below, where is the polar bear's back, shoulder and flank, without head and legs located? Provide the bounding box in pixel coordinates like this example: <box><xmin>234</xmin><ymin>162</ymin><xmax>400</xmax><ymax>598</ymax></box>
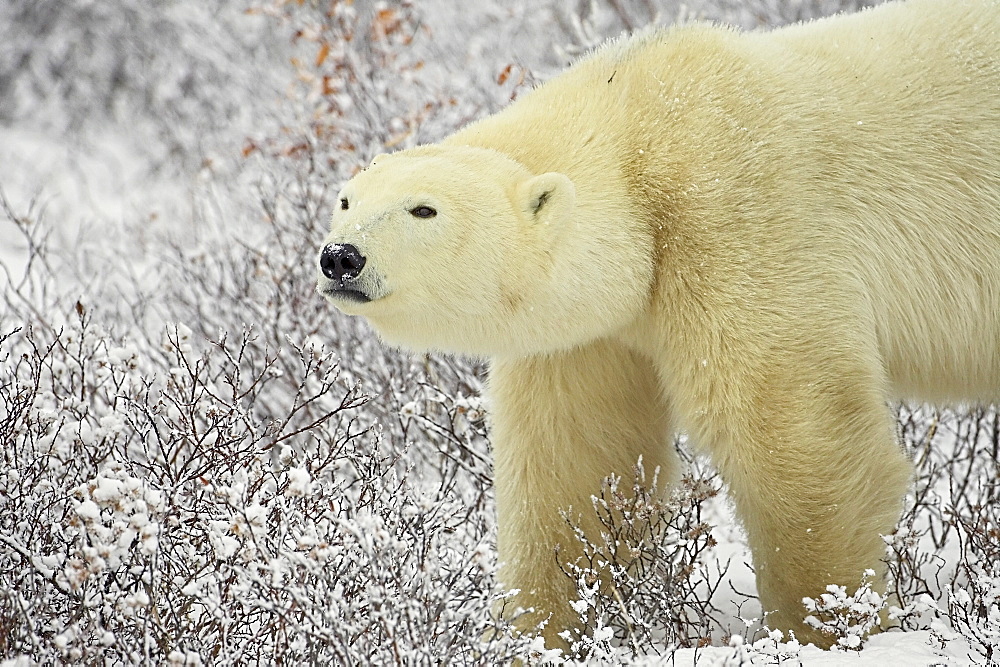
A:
<box><xmin>447</xmin><ymin>0</ymin><xmax>1000</xmax><ymax>400</ymax></box>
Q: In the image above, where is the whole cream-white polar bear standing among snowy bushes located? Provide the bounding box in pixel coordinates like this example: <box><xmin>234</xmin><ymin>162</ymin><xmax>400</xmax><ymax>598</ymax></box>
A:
<box><xmin>318</xmin><ymin>0</ymin><xmax>1000</xmax><ymax>645</ymax></box>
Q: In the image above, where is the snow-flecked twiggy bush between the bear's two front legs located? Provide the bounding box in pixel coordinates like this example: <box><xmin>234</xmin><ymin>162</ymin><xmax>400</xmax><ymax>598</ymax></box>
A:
<box><xmin>564</xmin><ymin>461</ymin><xmax>725</xmax><ymax>659</ymax></box>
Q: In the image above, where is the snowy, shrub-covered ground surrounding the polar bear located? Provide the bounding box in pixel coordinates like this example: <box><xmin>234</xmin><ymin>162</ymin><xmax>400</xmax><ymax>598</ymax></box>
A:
<box><xmin>0</xmin><ymin>0</ymin><xmax>1000</xmax><ymax>667</ymax></box>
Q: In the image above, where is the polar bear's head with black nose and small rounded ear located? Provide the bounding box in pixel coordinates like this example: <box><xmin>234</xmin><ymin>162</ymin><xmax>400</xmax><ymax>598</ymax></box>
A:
<box><xmin>317</xmin><ymin>145</ymin><xmax>652</xmax><ymax>356</ymax></box>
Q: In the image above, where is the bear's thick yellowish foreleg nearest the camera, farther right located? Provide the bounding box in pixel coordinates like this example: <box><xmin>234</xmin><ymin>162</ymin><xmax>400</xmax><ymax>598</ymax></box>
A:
<box><xmin>718</xmin><ymin>366</ymin><xmax>911</xmax><ymax>646</ymax></box>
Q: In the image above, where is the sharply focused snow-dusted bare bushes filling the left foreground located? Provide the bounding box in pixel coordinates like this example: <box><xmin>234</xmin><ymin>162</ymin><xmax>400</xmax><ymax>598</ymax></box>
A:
<box><xmin>0</xmin><ymin>308</ymin><xmax>532</xmax><ymax>664</ymax></box>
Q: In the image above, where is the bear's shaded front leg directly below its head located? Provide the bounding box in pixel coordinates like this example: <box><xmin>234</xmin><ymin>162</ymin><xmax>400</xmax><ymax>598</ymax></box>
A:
<box><xmin>489</xmin><ymin>341</ymin><xmax>677</xmax><ymax>649</ymax></box>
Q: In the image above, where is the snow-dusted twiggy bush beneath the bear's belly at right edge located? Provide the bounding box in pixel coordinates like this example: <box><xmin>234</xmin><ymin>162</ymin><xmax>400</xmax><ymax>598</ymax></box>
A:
<box><xmin>886</xmin><ymin>406</ymin><xmax>1000</xmax><ymax>663</ymax></box>
